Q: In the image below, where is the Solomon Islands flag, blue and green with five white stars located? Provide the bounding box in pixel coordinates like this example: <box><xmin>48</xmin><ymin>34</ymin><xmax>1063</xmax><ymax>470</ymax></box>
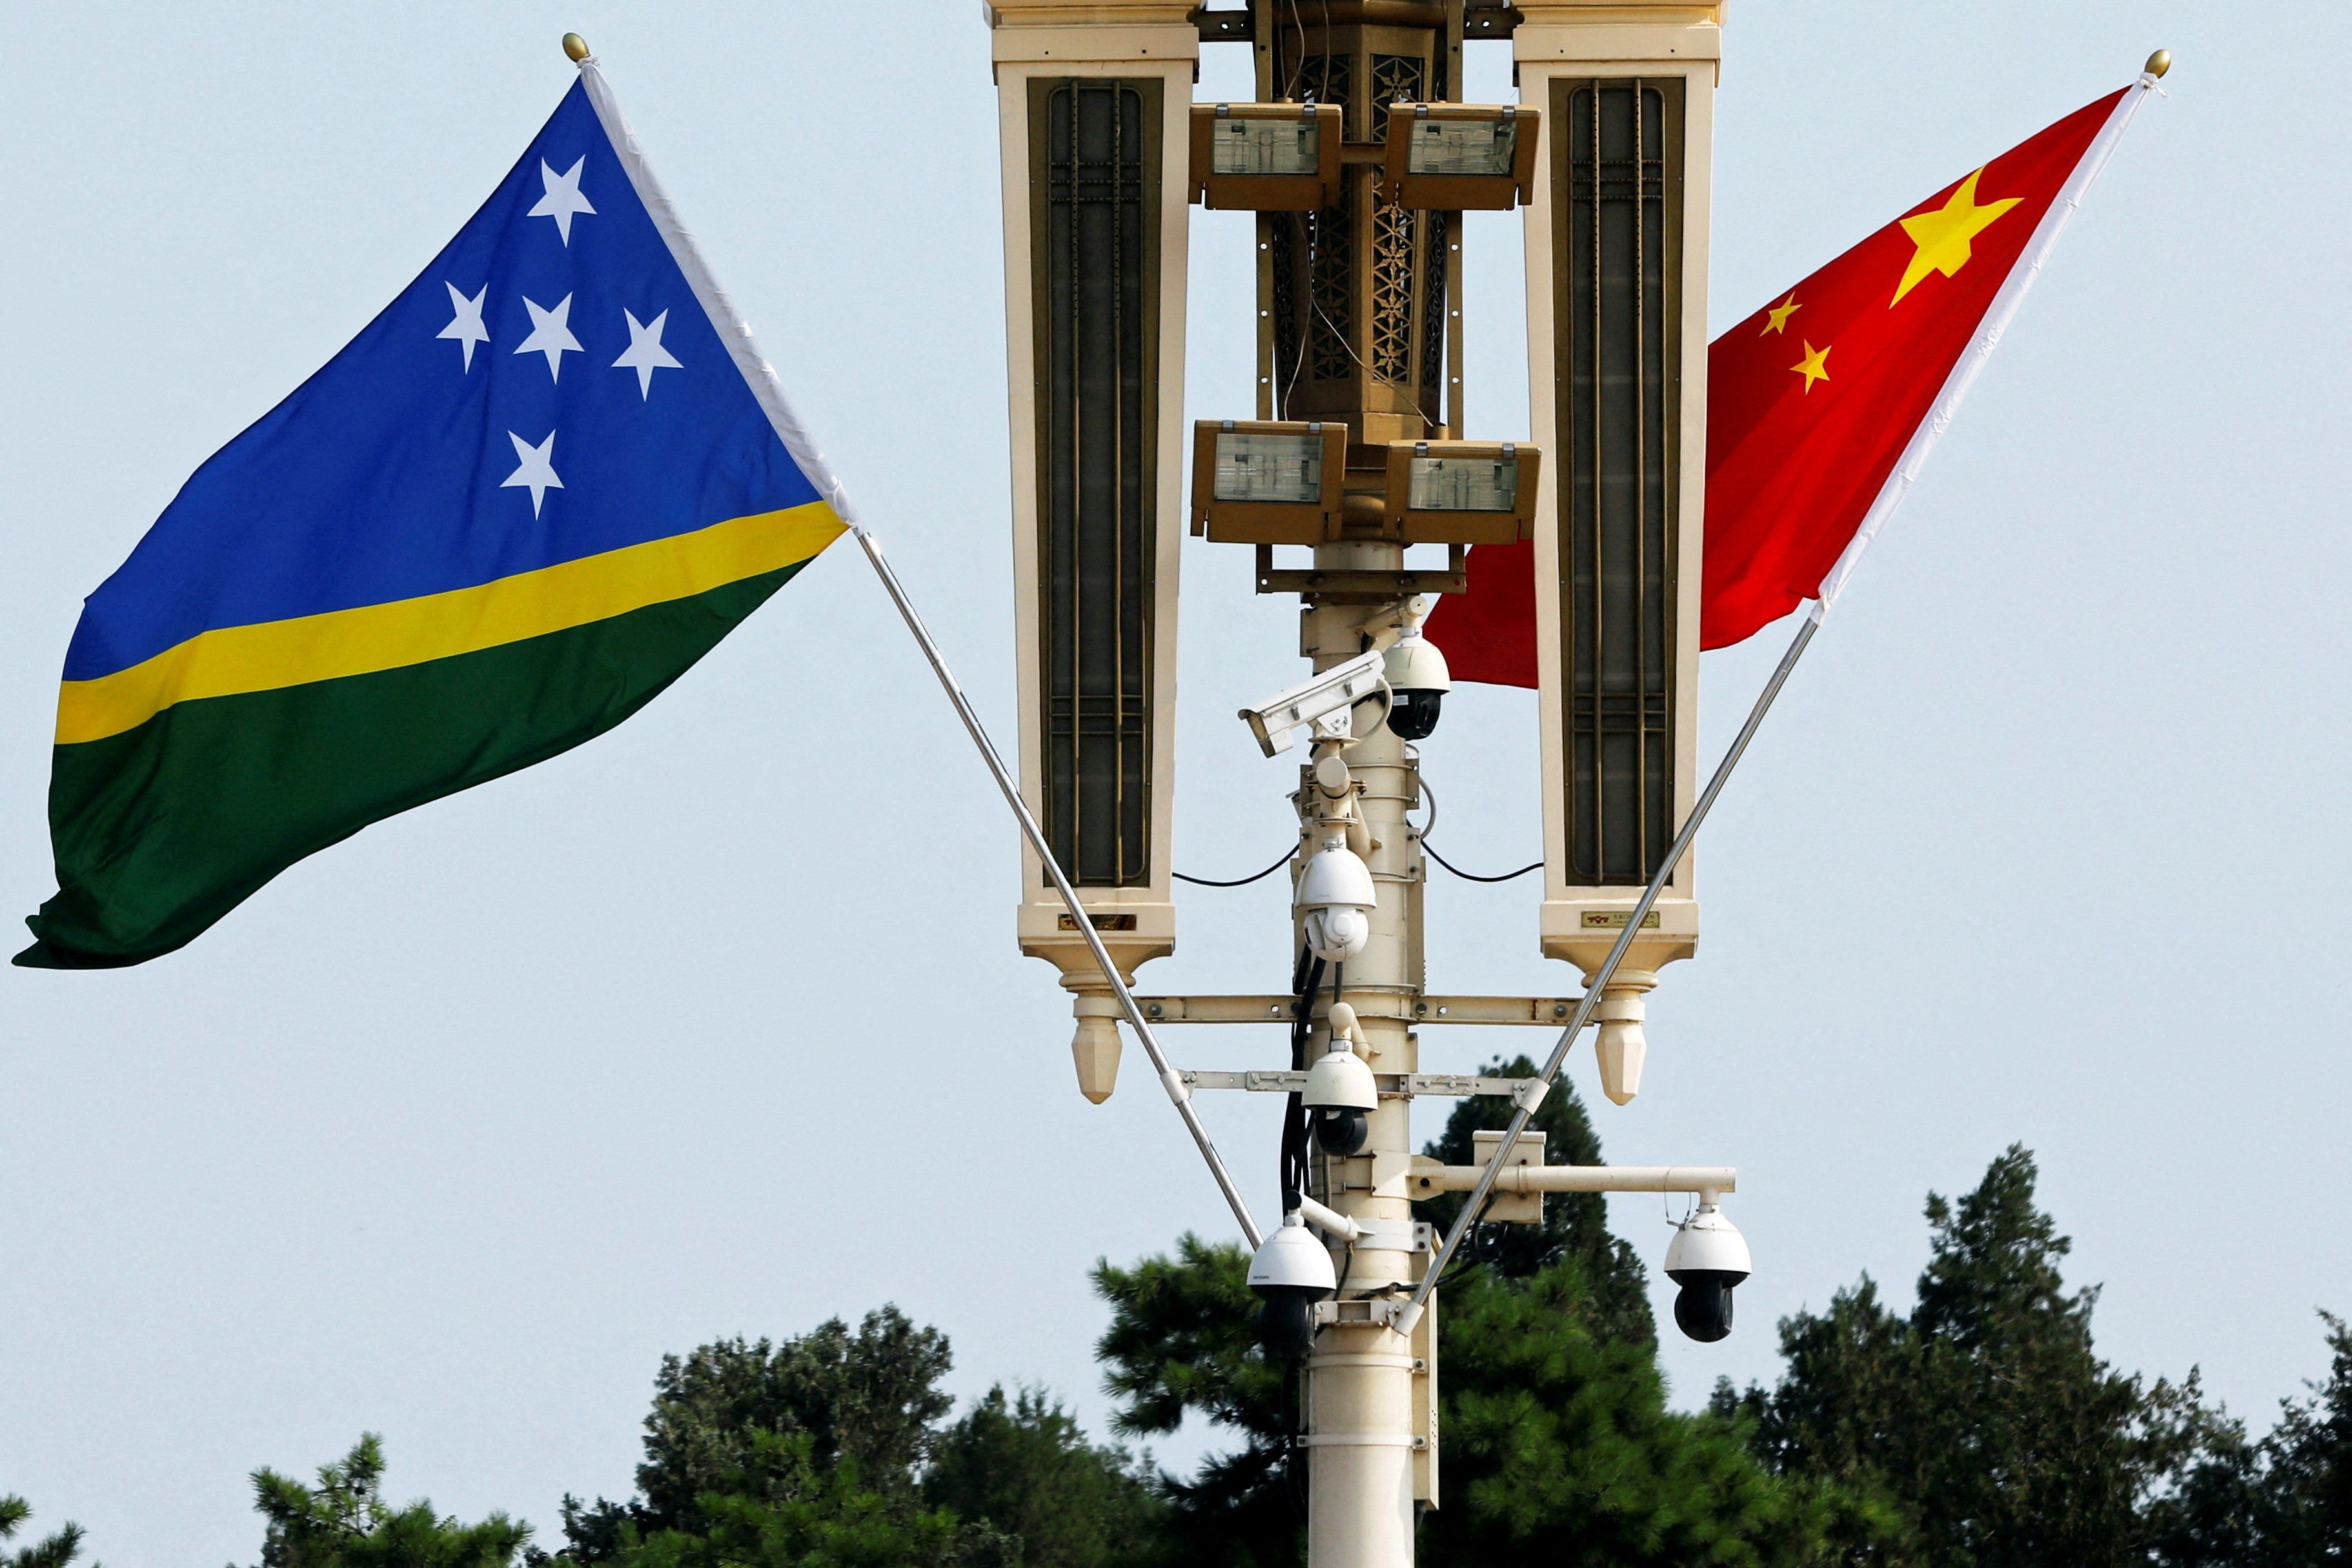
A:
<box><xmin>17</xmin><ymin>63</ymin><xmax>847</xmax><ymax>969</ymax></box>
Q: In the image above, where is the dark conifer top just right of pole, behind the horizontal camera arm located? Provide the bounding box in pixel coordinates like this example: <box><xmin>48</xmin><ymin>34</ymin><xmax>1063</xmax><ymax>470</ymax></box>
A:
<box><xmin>1414</xmin><ymin>1056</ymin><xmax>1658</xmax><ymax>1345</ymax></box>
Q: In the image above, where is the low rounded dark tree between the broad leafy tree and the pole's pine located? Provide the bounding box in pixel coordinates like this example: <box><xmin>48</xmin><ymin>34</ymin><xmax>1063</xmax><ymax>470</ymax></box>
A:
<box><xmin>922</xmin><ymin>1387</ymin><xmax>1164</xmax><ymax>1568</ymax></box>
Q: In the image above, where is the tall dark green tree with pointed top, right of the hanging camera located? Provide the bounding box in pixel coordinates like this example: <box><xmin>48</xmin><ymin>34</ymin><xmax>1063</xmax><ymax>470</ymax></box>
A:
<box><xmin>1750</xmin><ymin>1147</ymin><xmax>2227</xmax><ymax>1568</ymax></box>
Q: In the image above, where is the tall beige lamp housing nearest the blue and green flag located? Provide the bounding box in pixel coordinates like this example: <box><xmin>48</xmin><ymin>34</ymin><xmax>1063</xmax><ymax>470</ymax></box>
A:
<box><xmin>986</xmin><ymin>0</ymin><xmax>1199</xmax><ymax>1100</ymax></box>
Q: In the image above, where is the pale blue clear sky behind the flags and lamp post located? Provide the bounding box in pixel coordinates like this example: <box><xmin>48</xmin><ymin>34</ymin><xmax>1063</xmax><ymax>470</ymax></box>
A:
<box><xmin>0</xmin><ymin>0</ymin><xmax>2352</xmax><ymax>1568</ymax></box>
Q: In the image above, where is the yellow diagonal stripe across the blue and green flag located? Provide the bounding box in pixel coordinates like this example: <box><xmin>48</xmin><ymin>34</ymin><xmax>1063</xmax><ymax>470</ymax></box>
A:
<box><xmin>56</xmin><ymin>501</ymin><xmax>842</xmax><ymax>745</ymax></box>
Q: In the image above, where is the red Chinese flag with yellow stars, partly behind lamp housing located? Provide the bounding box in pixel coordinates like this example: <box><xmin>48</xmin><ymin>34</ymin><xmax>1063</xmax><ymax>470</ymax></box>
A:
<box><xmin>1430</xmin><ymin>87</ymin><xmax>2138</xmax><ymax>687</ymax></box>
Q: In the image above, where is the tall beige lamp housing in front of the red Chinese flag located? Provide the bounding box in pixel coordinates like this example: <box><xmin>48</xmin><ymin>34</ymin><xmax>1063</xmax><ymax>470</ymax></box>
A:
<box><xmin>1512</xmin><ymin>0</ymin><xmax>1724</xmax><ymax>1103</ymax></box>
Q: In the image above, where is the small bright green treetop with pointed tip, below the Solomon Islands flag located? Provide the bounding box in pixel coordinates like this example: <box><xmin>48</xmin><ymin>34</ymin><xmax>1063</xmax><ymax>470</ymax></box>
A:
<box><xmin>254</xmin><ymin>1432</ymin><xmax>532</xmax><ymax>1568</ymax></box>
